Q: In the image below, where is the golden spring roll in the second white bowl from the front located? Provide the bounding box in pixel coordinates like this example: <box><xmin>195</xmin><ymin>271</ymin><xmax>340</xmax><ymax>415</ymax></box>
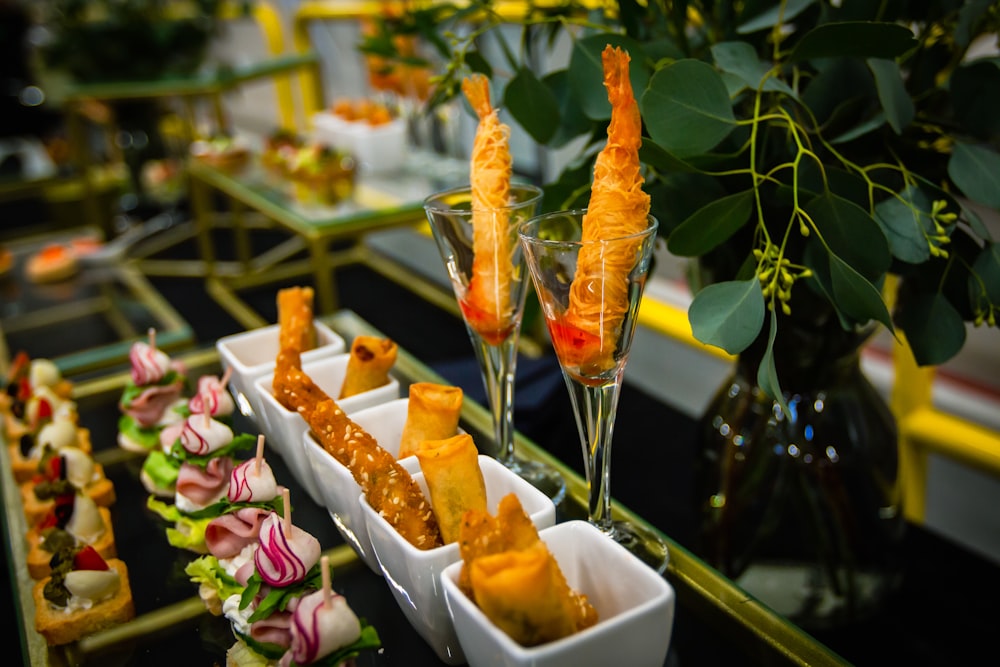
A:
<box><xmin>417</xmin><ymin>433</ymin><xmax>486</xmax><ymax>544</ymax></box>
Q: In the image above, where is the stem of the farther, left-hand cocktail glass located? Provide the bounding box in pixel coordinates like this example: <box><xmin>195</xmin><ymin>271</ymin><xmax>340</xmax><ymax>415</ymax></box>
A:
<box><xmin>469</xmin><ymin>331</ymin><xmax>517</xmax><ymax>465</ymax></box>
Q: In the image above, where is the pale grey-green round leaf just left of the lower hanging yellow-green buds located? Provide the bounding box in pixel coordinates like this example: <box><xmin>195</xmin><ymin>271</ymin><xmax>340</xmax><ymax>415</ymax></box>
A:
<box><xmin>688</xmin><ymin>277</ymin><xmax>764</xmax><ymax>354</ymax></box>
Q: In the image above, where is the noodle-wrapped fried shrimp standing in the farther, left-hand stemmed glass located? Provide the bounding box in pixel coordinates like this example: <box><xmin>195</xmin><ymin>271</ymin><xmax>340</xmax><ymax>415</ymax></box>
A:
<box><xmin>462</xmin><ymin>74</ymin><xmax>517</xmax><ymax>340</ymax></box>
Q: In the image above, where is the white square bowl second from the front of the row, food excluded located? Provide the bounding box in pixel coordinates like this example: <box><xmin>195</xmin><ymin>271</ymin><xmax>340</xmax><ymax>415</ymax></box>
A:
<box><xmin>359</xmin><ymin>454</ymin><xmax>556</xmax><ymax>665</ymax></box>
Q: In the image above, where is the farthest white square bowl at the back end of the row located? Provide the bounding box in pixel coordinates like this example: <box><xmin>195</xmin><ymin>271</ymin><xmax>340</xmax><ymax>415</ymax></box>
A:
<box><xmin>215</xmin><ymin>322</ymin><xmax>347</xmax><ymax>419</ymax></box>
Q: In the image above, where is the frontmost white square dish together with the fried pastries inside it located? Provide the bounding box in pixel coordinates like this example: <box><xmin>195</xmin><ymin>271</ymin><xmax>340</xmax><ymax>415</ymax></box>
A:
<box><xmin>441</xmin><ymin>516</ymin><xmax>675</xmax><ymax>667</ymax></box>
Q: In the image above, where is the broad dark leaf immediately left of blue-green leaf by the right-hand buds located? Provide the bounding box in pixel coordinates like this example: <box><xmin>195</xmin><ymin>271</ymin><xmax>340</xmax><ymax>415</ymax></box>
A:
<box><xmin>805</xmin><ymin>193</ymin><xmax>891</xmax><ymax>280</ymax></box>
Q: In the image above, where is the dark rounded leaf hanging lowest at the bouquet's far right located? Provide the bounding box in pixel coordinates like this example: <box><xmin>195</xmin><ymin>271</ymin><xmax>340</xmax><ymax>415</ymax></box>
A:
<box><xmin>896</xmin><ymin>294</ymin><xmax>966</xmax><ymax>366</ymax></box>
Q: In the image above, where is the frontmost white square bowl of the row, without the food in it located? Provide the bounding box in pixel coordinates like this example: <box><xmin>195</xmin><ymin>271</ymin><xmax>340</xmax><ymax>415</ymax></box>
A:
<box><xmin>441</xmin><ymin>521</ymin><xmax>676</xmax><ymax>667</ymax></box>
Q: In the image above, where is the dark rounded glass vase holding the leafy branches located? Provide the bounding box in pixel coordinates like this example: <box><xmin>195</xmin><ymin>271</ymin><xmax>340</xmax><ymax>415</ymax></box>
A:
<box><xmin>695</xmin><ymin>317</ymin><xmax>905</xmax><ymax>631</ymax></box>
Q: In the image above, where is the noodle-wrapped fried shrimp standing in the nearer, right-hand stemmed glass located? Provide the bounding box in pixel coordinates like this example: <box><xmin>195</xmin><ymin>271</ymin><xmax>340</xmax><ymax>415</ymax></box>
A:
<box><xmin>566</xmin><ymin>45</ymin><xmax>650</xmax><ymax>373</ymax></box>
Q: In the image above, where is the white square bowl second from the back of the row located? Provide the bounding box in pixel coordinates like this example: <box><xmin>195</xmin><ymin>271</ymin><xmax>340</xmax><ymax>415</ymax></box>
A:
<box><xmin>253</xmin><ymin>352</ymin><xmax>399</xmax><ymax>505</ymax></box>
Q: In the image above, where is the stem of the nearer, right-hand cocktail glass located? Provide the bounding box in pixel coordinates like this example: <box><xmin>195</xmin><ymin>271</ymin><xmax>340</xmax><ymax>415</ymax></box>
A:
<box><xmin>564</xmin><ymin>376</ymin><xmax>621</xmax><ymax>535</ymax></box>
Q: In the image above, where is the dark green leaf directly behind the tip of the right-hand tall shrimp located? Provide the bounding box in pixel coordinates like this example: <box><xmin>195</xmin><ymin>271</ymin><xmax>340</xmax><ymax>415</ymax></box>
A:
<box><xmin>569</xmin><ymin>33</ymin><xmax>649</xmax><ymax>120</ymax></box>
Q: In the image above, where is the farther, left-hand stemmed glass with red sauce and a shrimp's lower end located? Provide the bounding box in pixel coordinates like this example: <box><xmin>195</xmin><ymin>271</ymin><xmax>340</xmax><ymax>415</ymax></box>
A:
<box><xmin>424</xmin><ymin>184</ymin><xmax>566</xmax><ymax>504</ymax></box>
